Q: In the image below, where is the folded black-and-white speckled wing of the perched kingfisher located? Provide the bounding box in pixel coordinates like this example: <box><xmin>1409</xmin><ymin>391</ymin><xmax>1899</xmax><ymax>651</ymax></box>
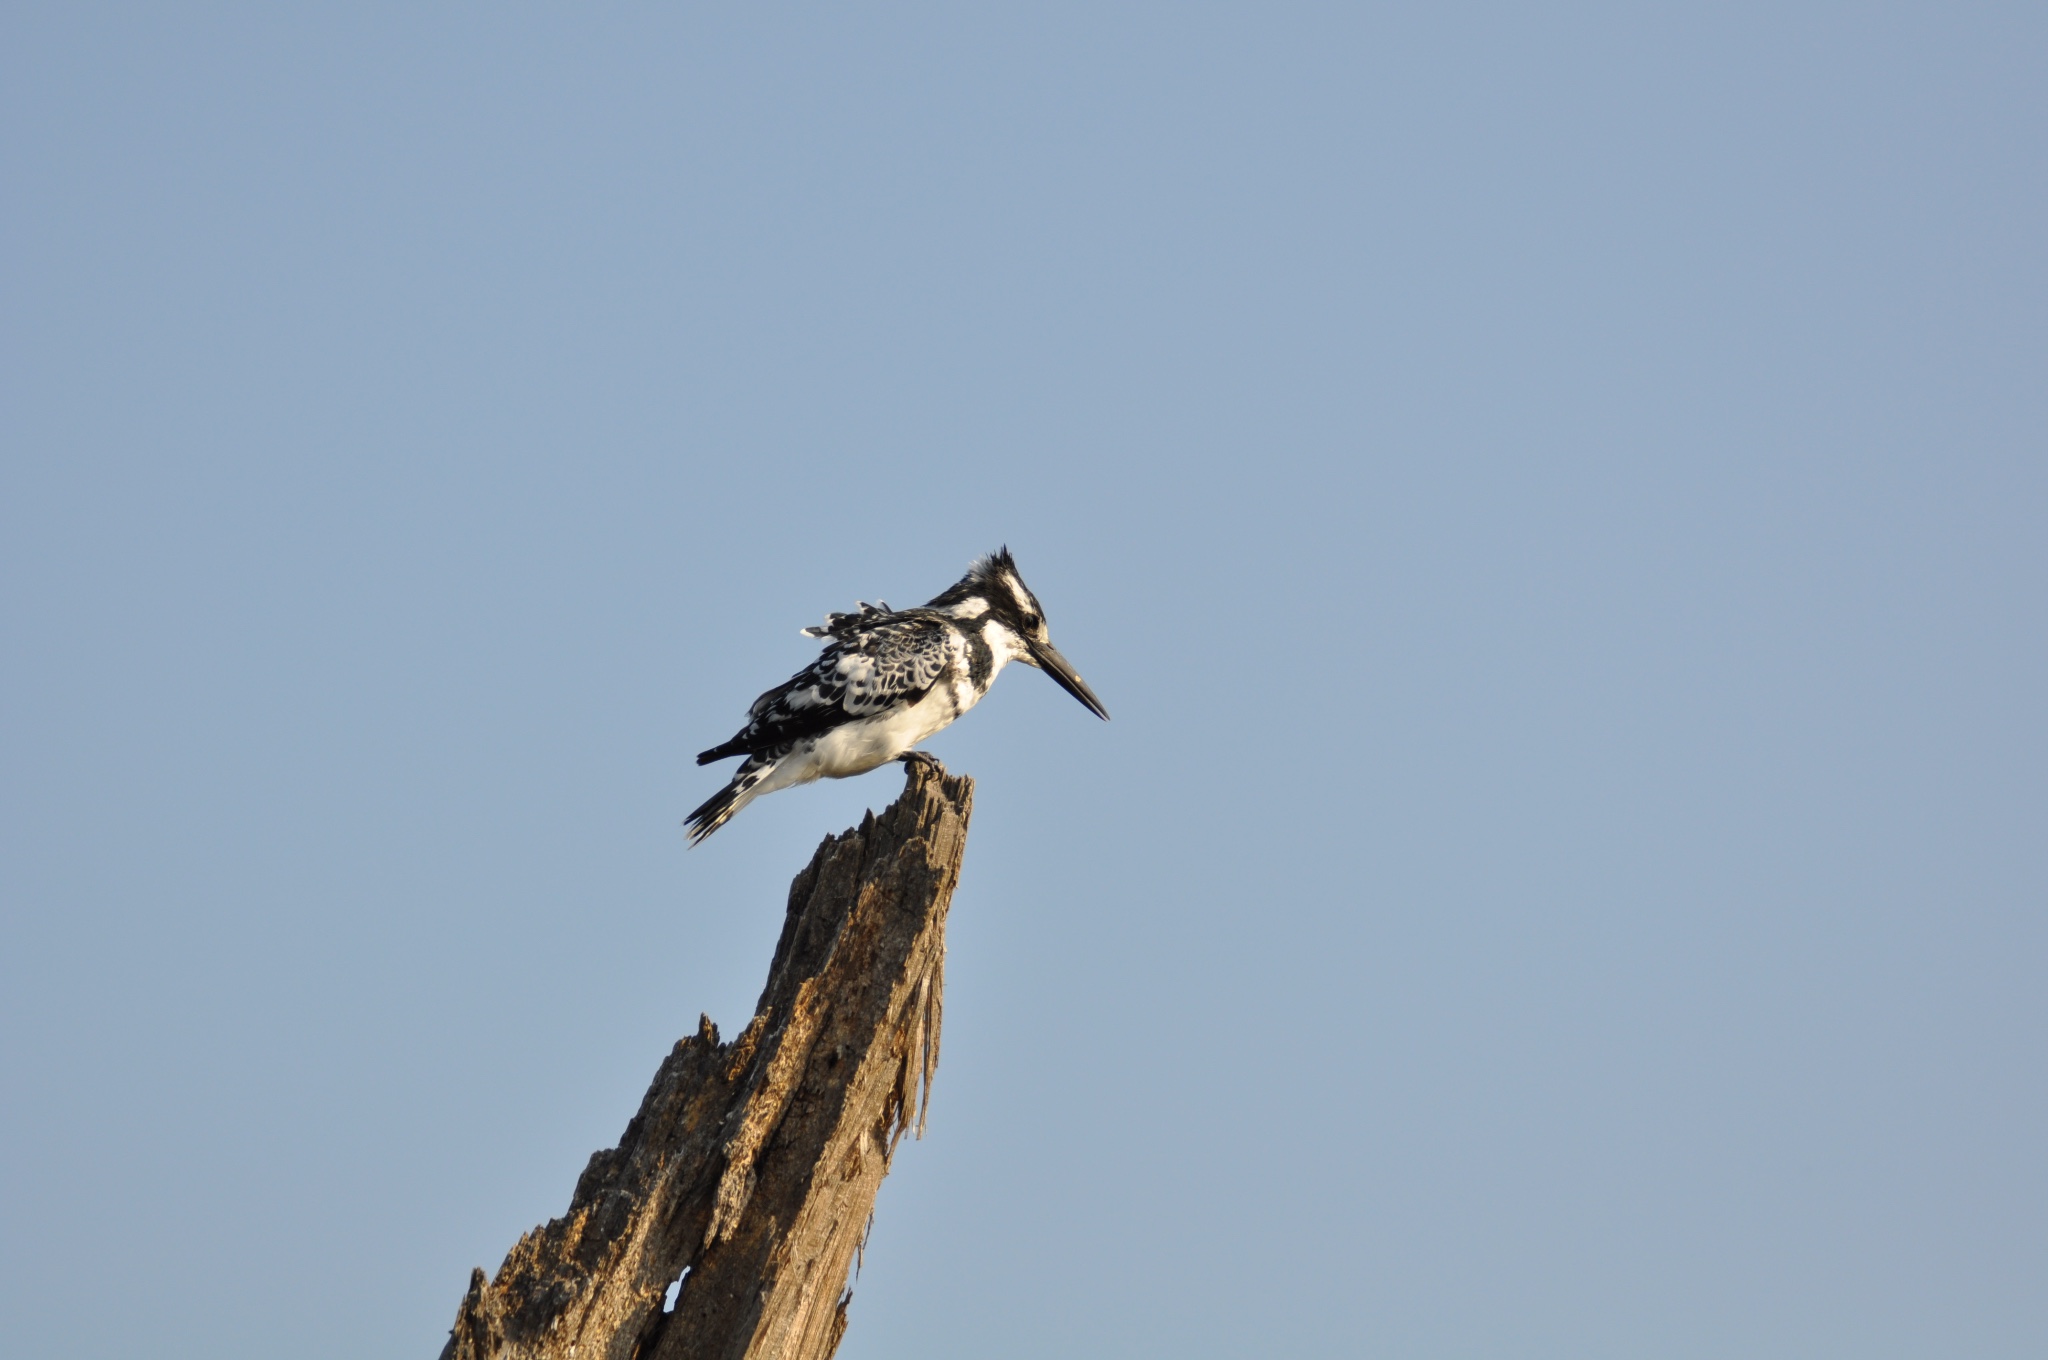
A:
<box><xmin>696</xmin><ymin>604</ymin><xmax>950</xmax><ymax>764</ymax></box>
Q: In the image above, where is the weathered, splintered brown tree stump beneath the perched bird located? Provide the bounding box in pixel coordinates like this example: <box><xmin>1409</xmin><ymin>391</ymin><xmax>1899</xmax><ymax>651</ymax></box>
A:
<box><xmin>440</xmin><ymin>764</ymin><xmax>973</xmax><ymax>1360</ymax></box>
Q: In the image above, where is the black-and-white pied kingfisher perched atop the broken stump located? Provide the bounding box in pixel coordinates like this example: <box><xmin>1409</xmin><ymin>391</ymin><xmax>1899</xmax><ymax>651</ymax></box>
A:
<box><xmin>688</xmin><ymin>549</ymin><xmax>1110</xmax><ymax>846</ymax></box>
